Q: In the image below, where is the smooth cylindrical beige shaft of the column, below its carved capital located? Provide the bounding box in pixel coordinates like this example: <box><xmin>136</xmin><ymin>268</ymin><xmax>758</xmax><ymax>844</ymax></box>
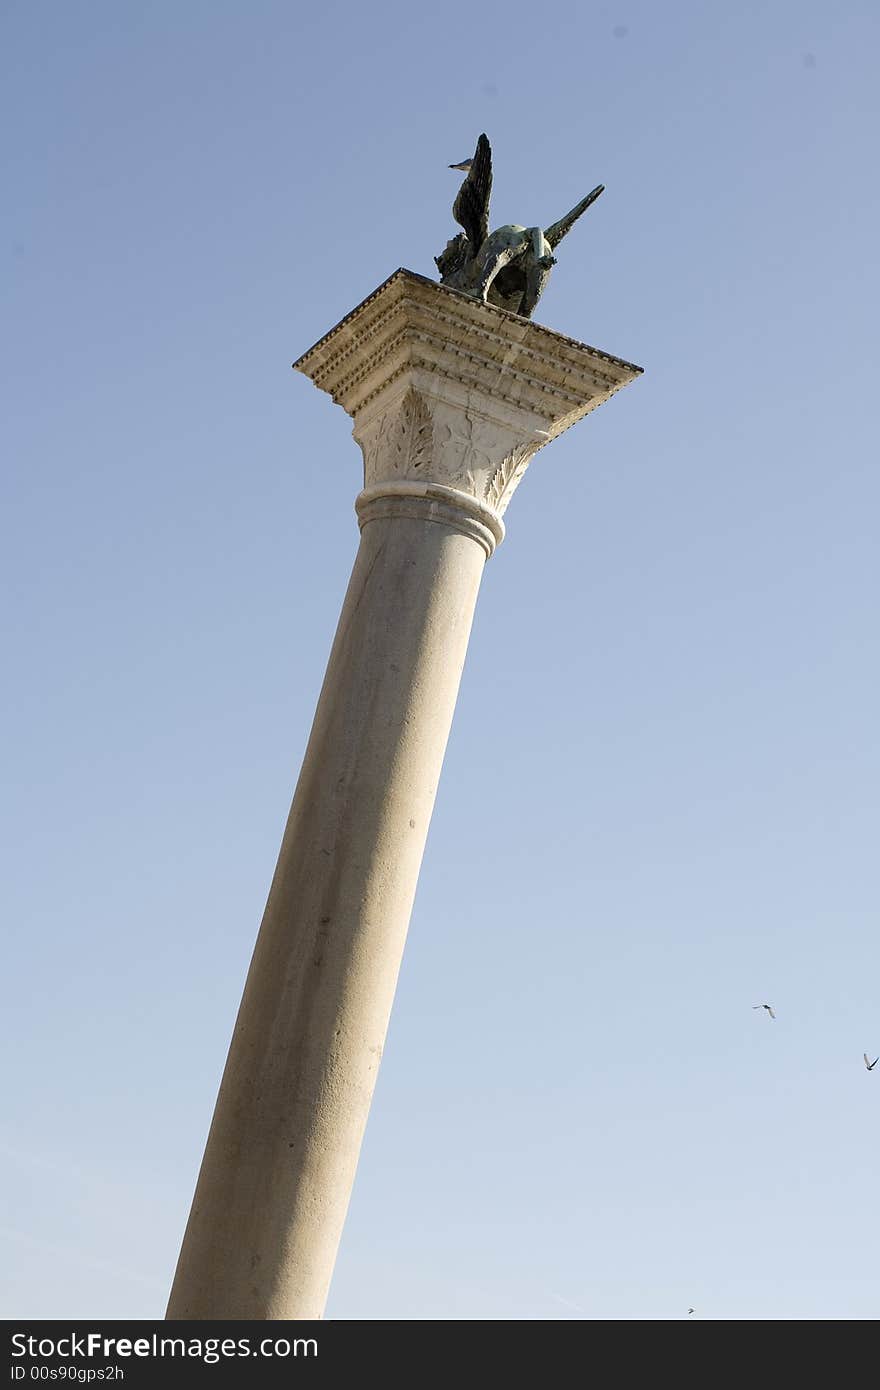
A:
<box><xmin>168</xmin><ymin>499</ymin><xmax>487</xmax><ymax>1319</ymax></box>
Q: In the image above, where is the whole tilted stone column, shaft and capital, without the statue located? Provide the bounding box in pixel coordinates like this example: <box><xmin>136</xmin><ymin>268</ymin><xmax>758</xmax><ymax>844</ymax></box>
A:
<box><xmin>167</xmin><ymin>270</ymin><xmax>639</xmax><ymax>1319</ymax></box>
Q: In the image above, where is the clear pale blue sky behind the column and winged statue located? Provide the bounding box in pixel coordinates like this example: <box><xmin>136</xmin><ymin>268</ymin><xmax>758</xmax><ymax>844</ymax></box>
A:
<box><xmin>0</xmin><ymin>0</ymin><xmax>880</xmax><ymax>1319</ymax></box>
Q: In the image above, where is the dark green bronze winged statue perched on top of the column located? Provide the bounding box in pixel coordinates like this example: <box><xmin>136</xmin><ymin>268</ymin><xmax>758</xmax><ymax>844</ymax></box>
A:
<box><xmin>434</xmin><ymin>135</ymin><xmax>605</xmax><ymax>318</ymax></box>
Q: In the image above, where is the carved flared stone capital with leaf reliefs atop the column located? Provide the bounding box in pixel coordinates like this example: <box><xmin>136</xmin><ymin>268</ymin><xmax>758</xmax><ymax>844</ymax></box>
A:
<box><xmin>293</xmin><ymin>270</ymin><xmax>641</xmax><ymax>534</ymax></box>
